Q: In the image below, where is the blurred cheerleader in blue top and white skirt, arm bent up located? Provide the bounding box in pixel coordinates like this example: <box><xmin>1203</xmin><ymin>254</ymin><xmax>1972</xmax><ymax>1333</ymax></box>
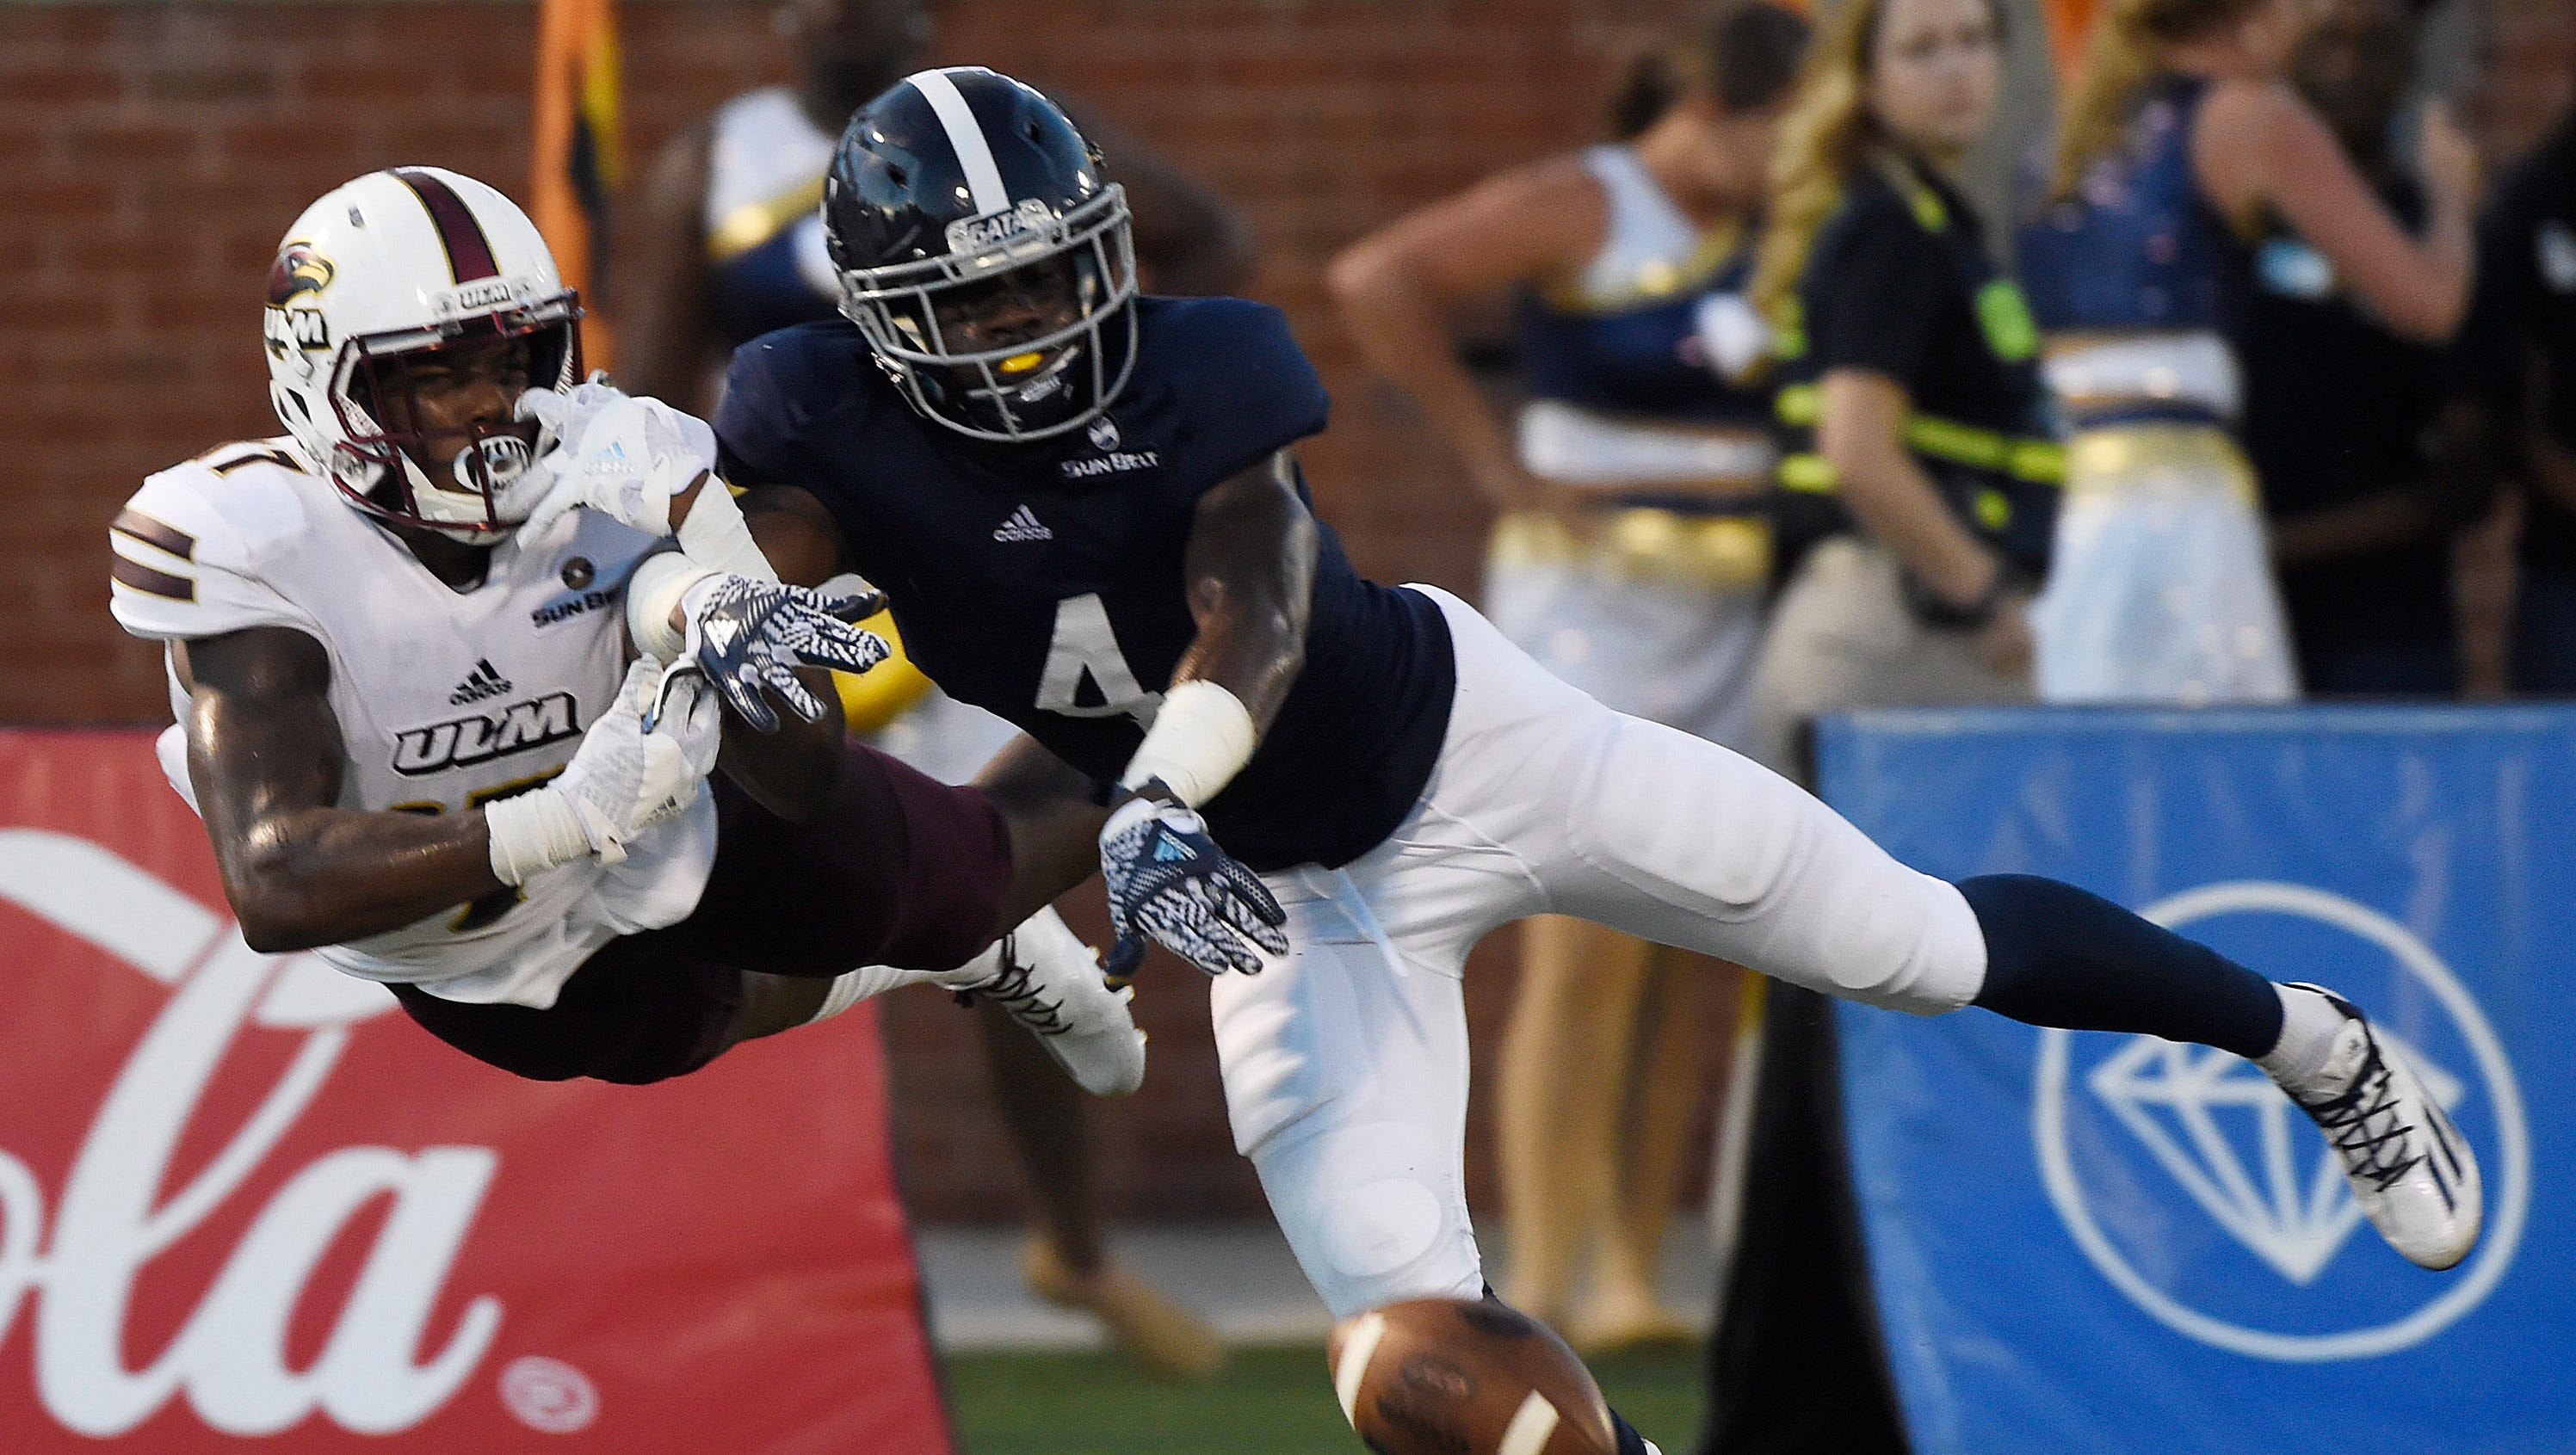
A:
<box><xmin>2020</xmin><ymin>0</ymin><xmax>2475</xmax><ymax>703</ymax></box>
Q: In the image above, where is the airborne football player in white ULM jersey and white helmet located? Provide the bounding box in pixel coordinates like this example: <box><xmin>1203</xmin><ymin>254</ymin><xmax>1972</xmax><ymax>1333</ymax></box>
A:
<box><xmin>111</xmin><ymin>168</ymin><xmax>1144</xmax><ymax>1094</ymax></box>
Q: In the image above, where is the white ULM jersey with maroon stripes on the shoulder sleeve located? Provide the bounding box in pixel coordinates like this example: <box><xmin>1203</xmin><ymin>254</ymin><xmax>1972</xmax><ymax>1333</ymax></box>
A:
<box><xmin>111</xmin><ymin>438</ymin><xmax>716</xmax><ymax>1007</ymax></box>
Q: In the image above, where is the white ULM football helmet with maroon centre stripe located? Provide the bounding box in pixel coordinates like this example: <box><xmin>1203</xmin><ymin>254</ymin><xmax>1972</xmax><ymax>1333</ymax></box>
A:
<box><xmin>263</xmin><ymin>168</ymin><xmax>582</xmax><ymax>541</ymax></box>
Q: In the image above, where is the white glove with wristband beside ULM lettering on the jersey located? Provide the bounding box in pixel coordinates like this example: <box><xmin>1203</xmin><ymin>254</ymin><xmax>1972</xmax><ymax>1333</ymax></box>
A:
<box><xmin>485</xmin><ymin>657</ymin><xmax>721</xmax><ymax>884</ymax></box>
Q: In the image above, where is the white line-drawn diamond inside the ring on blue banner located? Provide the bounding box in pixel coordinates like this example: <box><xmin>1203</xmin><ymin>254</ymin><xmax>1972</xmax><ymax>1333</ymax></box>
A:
<box><xmin>2086</xmin><ymin>1027</ymin><xmax>2465</xmax><ymax>1287</ymax></box>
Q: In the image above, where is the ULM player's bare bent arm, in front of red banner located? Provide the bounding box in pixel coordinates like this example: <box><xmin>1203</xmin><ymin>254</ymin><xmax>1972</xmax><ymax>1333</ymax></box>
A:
<box><xmin>173</xmin><ymin>626</ymin><xmax>505</xmax><ymax>953</ymax></box>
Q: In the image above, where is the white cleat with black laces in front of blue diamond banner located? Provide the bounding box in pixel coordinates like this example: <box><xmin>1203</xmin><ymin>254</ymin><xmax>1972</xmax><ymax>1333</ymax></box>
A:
<box><xmin>2280</xmin><ymin>983</ymin><xmax>2486</xmax><ymax>1270</ymax></box>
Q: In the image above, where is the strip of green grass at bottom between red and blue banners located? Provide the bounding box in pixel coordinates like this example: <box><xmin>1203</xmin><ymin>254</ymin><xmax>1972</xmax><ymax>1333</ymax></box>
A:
<box><xmin>942</xmin><ymin>1347</ymin><xmax>1700</xmax><ymax>1455</ymax></box>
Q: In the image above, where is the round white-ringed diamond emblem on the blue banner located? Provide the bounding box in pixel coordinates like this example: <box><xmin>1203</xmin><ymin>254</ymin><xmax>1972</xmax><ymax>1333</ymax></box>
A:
<box><xmin>2032</xmin><ymin>881</ymin><xmax>2532</xmax><ymax>1362</ymax></box>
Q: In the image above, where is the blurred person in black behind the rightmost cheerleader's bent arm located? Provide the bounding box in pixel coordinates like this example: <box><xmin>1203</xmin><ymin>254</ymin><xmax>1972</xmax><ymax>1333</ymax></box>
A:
<box><xmin>2244</xmin><ymin>0</ymin><xmax>2491</xmax><ymax>695</ymax></box>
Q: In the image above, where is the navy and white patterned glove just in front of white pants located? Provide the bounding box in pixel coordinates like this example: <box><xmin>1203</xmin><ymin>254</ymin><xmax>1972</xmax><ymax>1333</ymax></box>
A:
<box><xmin>1100</xmin><ymin>780</ymin><xmax>1288</xmax><ymax>983</ymax></box>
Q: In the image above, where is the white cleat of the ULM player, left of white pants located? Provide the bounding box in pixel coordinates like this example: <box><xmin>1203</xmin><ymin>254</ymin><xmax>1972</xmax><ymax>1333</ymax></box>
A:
<box><xmin>940</xmin><ymin>909</ymin><xmax>1144</xmax><ymax>1097</ymax></box>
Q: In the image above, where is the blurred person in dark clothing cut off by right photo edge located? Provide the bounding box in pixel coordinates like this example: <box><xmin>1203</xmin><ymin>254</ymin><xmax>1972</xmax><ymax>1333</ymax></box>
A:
<box><xmin>2462</xmin><ymin>111</ymin><xmax>2576</xmax><ymax>695</ymax></box>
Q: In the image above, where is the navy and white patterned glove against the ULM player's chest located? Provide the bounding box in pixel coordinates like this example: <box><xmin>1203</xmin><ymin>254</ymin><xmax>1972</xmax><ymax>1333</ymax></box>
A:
<box><xmin>680</xmin><ymin>571</ymin><xmax>894</xmax><ymax>731</ymax></box>
